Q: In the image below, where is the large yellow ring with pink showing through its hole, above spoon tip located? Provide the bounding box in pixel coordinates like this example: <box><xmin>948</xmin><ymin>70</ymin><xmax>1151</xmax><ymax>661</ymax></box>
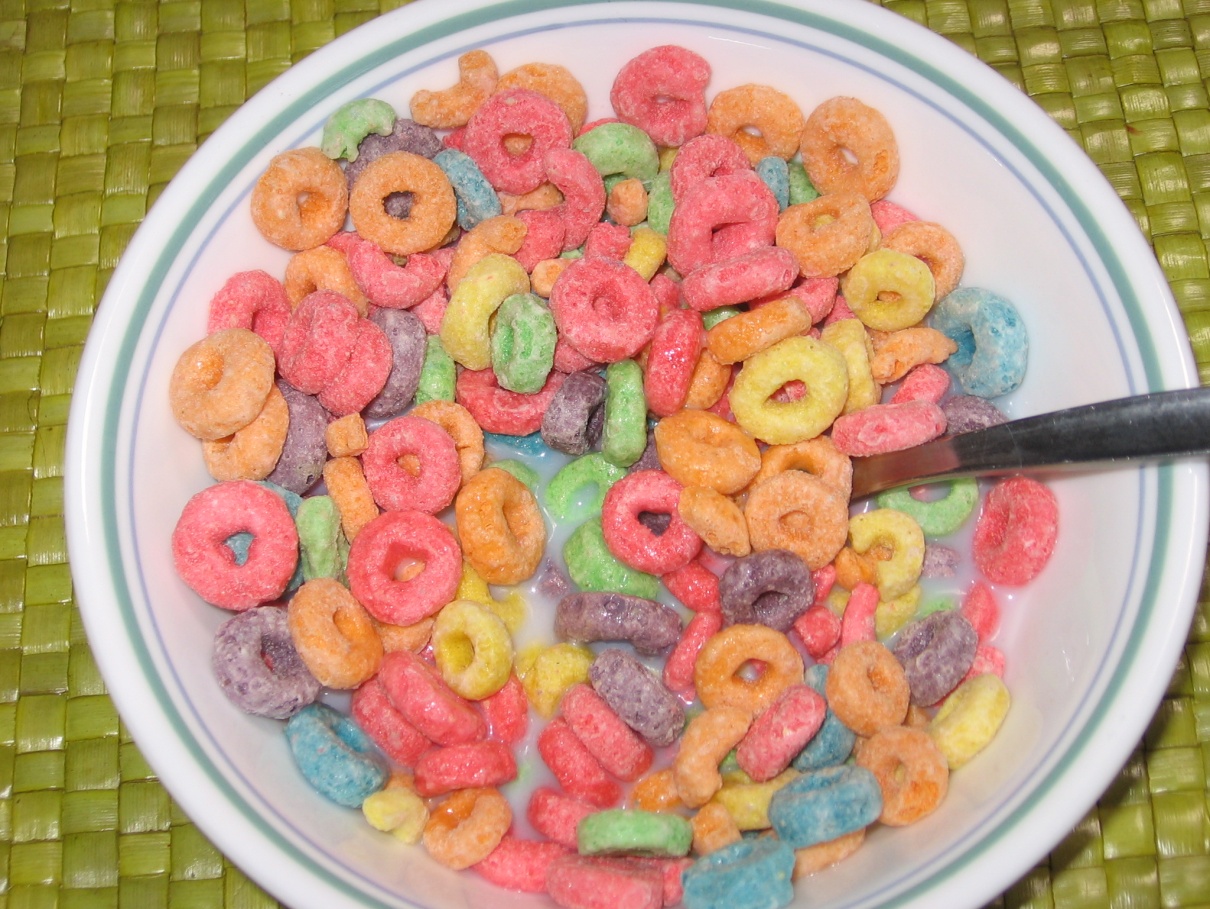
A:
<box><xmin>731</xmin><ymin>338</ymin><xmax>848</xmax><ymax>445</ymax></box>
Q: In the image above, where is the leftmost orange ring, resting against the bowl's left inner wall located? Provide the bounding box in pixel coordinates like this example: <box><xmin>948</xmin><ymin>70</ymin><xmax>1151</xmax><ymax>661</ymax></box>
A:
<box><xmin>168</xmin><ymin>328</ymin><xmax>276</xmax><ymax>439</ymax></box>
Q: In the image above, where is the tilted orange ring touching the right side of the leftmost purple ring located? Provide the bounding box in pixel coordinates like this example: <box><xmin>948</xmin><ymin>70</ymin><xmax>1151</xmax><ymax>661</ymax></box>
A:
<box><xmin>287</xmin><ymin>577</ymin><xmax>382</xmax><ymax>689</ymax></box>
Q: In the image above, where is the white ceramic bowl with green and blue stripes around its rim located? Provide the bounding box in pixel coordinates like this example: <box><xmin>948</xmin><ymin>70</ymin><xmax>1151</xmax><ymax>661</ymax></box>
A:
<box><xmin>67</xmin><ymin>0</ymin><xmax>1206</xmax><ymax>909</ymax></box>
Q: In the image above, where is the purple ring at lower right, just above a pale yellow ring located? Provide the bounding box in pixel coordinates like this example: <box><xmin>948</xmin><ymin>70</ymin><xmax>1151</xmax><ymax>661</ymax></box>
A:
<box><xmin>891</xmin><ymin>609</ymin><xmax>979</xmax><ymax>707</ymax></box>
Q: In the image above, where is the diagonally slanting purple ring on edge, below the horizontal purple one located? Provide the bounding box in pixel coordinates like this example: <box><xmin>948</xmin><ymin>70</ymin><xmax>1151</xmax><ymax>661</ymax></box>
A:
<box><xmin>588</xmin><ymin>650</ymin><xmax>685</xmax><ymax>748</ymax></box>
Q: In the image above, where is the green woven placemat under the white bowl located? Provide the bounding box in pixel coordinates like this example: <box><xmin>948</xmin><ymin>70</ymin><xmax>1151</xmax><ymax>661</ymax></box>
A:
<box><xmin>0</xmin><ymin>0</ymin><xmax>1210</xmax><ymax>909</ymax></box>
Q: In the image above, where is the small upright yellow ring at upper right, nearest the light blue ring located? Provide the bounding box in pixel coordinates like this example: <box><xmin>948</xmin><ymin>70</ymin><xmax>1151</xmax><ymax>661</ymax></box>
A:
<box><xmin>840</xmin><ymin>249</ymin><xmax>934</xmax><ymax>332</ymax></box>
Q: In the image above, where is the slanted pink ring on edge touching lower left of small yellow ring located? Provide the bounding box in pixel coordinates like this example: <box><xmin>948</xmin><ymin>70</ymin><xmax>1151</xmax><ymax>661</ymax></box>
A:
<box><xmin>378</xmin><ymin>650</ymin><xmax>488</xmax><ymax>746</ymax></box>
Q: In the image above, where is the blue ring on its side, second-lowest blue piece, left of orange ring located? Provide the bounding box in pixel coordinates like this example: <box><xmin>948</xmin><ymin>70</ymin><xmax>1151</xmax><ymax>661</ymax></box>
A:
<box><xmin>768</xmin><ymin>764</ymin><xmax>882</xmax><ymax>848</ymax></box>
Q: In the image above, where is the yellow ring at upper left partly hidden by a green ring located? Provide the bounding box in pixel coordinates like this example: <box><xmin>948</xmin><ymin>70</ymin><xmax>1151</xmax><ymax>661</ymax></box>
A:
<box><xmin>440</xmin><ymin>253</ymin><xmax>530</xmax><ymax>369</ymax></box>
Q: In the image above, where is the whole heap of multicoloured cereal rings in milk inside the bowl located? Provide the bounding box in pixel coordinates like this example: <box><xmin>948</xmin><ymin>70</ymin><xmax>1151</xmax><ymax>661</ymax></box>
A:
<box><xmin>169</xmin><ymin>46</ymin><xmax>1059</xmax><ymax>909</ymax></box>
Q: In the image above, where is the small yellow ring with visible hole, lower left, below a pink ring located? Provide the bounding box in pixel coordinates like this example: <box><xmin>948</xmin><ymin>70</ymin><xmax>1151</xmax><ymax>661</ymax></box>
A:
<box><xmin>433</xmin><ymin>599</ymin><xmax>513</xmax><ymax>701</ymax></box>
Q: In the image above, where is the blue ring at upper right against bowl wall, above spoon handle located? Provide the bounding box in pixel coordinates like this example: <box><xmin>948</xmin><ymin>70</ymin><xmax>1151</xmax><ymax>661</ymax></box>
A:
<box><xmin>932</xmin><ymin>287</ymin><xmax>1030</xmax><ymax>398</ymax></box>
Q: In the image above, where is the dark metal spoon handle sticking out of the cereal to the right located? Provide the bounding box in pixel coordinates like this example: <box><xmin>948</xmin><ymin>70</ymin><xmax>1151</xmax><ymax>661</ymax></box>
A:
<box><xmin>853</xmin><ymin>389</ymin><xmax>1210</xmax><ymax>499</ymax></box>
